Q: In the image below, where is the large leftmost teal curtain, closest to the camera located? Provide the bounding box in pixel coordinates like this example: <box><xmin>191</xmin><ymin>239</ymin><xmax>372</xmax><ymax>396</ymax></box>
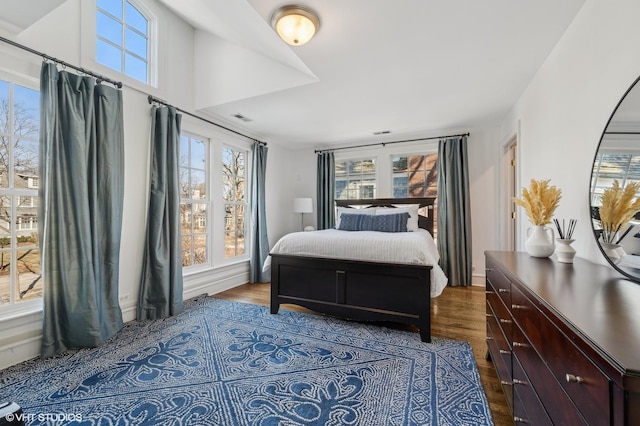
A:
<box><xmin>38</xmin><ymin>63</ymin><xmax>124</xmax><ymax>357</ymax></box>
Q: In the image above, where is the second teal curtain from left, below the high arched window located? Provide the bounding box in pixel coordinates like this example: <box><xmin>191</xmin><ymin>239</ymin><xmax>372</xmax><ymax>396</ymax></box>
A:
<box><xmin>138</xmin><ymin>106</ymin><xmax>183</xmax><ymax>320</ymax></box>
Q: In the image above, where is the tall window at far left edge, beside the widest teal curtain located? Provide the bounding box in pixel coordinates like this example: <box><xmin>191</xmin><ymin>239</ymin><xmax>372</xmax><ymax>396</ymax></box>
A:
<box><xmin>0</xmin><ymin>80</ymin><xmax>43</xmax><ymax>308</ymax></box>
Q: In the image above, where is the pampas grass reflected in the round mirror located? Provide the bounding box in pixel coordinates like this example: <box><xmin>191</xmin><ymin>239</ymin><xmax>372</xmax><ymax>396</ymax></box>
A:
<box><xmin>600</xmin><ymin>179</ymin><xmax>640</xmax><ymax>243</ymax></box>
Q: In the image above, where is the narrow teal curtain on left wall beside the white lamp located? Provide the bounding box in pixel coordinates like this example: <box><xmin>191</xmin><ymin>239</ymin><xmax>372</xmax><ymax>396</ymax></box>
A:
<box><xmin>249</xmin><ymin>142</ymin><xmax>271</xmax><ymax>283</ymax></box>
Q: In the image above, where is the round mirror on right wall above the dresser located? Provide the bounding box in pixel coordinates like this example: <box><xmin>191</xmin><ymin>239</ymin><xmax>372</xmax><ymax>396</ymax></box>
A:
<box><xmin>590</xmin><ymin>78</ymin><xmax>640</xmax><ymax>282</ymax></box>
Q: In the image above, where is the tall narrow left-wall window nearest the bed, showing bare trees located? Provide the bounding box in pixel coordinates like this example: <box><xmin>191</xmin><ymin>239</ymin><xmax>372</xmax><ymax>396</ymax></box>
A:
<box><xmin>222</xmin><ymin>147</ymin><xmax>247</xmax><ymax>259</ymax></box>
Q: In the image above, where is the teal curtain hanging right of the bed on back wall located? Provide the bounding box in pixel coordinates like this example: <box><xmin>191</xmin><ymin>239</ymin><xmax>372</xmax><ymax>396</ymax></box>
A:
<box><xmin>437</xmin><ymin>136</ymin><xmax>472</xmax><ymax>286</ymax></box>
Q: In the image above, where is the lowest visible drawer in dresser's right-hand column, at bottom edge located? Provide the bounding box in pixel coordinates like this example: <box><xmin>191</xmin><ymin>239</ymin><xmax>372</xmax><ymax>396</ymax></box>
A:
<box><xmin>513</xmin><ymin>357</ymin><xmax>553</xmax><ymax>426</ymax></box>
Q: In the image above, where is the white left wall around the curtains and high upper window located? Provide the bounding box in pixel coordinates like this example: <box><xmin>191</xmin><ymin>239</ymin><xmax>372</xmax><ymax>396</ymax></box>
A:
<box><xmin>0</xmin><ymin>0</ymin><xmax>262</xmax><ymax>368</ymax></box>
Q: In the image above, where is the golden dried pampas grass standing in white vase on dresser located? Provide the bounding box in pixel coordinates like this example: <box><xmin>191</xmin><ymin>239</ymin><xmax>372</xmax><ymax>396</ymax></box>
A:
<box><xmin>513</xmin><ymin>179</ymin><xmax>562</xmax><ymax>226</ymax></box>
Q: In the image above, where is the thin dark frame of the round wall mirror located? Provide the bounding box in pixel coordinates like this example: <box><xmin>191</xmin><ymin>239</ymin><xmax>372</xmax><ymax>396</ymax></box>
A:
<box><xmin>589</xmin><ymin>77</ymin><xmax>640</xmax><ymax>283</ymax></box>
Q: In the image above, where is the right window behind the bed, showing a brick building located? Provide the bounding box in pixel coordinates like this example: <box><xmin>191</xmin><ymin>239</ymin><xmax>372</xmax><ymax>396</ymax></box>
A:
<box><xmin>391</xmin><ymin>154</ymin><xmax>438</xmax><ymax>198</ymax></box>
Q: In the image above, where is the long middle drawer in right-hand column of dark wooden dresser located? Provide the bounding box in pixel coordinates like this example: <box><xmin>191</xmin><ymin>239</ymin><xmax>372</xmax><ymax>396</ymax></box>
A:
<box><xmin>513</xmin><ymin>325</ymin><xmax>588</xmax><ymax>425</ymax></box>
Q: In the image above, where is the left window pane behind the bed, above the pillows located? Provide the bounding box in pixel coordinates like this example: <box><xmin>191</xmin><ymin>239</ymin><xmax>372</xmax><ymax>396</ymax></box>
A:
<box><xmin>335</xmin><ymin>158</ymin><xmax>376</xmax><ymax>200</ymax></box>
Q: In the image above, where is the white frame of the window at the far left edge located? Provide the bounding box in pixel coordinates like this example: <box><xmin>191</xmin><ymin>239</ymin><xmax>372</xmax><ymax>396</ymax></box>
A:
<box><xmin>0</xmin><ymin>70</ymin><xmax>44</xmax><ymax>320</ymax></box>
